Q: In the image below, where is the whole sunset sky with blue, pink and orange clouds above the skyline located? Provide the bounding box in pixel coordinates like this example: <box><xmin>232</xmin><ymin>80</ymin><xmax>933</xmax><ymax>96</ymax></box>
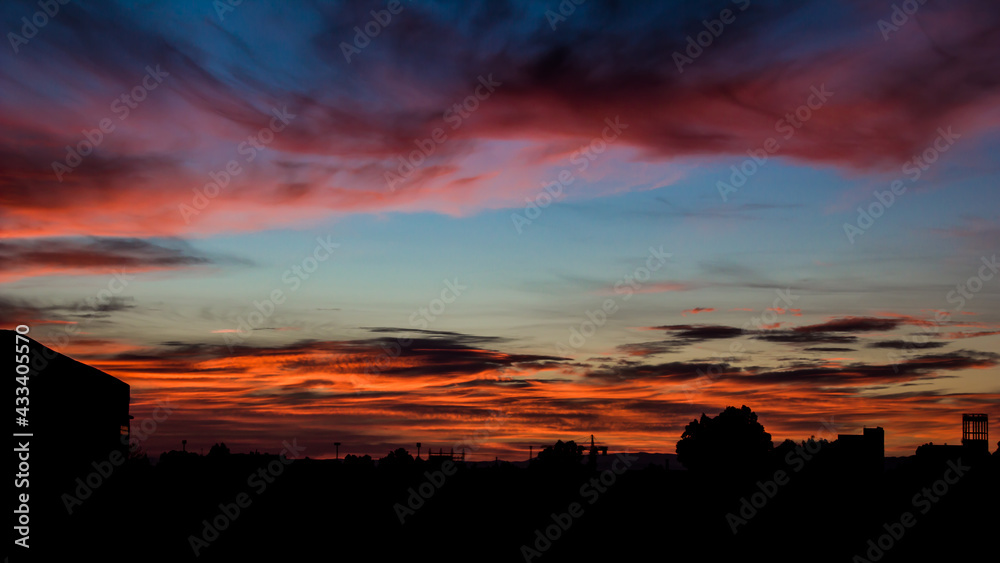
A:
<box><xmin>0</xmin><ymin>0</ymin><xmax>1000</xmax><ymax>459</ymax></box>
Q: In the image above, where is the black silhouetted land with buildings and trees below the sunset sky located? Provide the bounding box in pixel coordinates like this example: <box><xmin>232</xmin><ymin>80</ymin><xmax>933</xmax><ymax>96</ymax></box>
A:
<box><xmin>7</xmin><ymin>328</ymin><xmax>1000</xmax><ymax>561</ymax></box>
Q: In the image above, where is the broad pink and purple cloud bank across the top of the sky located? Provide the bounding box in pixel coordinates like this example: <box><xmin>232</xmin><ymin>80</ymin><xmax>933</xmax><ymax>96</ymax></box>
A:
<box><xmin>0</xmin><ymin>1</ymin><xmax>1000</xmax><ymax>239</ymax></box>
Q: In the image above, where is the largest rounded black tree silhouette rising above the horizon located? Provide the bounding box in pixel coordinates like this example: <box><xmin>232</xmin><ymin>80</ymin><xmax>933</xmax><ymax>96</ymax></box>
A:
<box><xmin>677</xmin><ymin>405</ymin><xmax>774</xmax><ymax>473</ymax></box>
